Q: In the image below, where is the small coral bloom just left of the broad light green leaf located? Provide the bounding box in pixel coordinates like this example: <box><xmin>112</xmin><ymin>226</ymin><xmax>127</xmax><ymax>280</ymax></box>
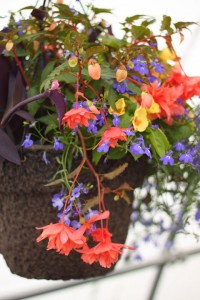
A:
<box><xmin>99</xmin><ymin>127</ymin><xmax>127</xmax><ymax>148</ymax></box>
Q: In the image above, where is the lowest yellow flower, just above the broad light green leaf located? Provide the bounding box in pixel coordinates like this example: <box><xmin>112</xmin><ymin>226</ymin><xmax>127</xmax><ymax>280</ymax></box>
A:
<box><xmin>132</xmin><ymin>106</ymin><xmax>149</xmax><ymax>132</ymax></box>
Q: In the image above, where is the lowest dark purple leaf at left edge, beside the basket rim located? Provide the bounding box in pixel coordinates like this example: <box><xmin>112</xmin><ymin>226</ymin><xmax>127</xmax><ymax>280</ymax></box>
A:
<box><xmin>0</xmin><ymin>129</ymin><xmax>21</xmax><ymax>165</ymax></box>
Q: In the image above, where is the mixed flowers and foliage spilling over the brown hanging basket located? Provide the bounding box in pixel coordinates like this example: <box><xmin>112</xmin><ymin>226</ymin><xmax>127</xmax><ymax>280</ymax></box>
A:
<box><xmin>0</xmin><ymin>1</ymin><xmax>200</xmax><ymax>268</ymax></box>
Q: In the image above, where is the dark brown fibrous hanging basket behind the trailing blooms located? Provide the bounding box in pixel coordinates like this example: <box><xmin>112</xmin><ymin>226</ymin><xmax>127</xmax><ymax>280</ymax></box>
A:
<box><xmin>0</xmin><ymin>151</ymin><xmax>146</xmax><ymax>280</ymax></box>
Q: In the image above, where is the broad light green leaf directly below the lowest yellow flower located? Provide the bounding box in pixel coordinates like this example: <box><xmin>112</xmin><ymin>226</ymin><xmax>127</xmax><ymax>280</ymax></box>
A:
<box><xmin>147</xmin><ymin>127</ymin><xmax>170</xmax><ymax>157</ymax></box>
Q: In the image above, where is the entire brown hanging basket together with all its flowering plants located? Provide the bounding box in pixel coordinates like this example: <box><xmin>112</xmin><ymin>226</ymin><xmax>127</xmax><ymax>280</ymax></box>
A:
<box><xmin>0</xmin><ymin>1</ymin><xmax>200</xmax><ymax>279</ymax></box>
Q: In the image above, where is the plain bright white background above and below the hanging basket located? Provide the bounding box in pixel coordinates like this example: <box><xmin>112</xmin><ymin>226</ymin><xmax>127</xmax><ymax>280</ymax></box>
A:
<box><xmin>0</xmin><ymin>0</ymin><xmax>200</xmax><ymax>300</ymax></box>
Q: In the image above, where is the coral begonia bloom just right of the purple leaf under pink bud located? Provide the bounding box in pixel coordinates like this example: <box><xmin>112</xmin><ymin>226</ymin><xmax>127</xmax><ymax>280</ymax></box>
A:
<box><xmin>62</xmin><ymin>107</ymin><xmax>97</xmax><ymax>129</ymax></box>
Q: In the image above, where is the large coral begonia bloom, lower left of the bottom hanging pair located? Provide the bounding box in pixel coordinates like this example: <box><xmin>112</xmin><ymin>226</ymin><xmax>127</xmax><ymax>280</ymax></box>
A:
<box><xmin>36</xmin><ymin>223</ymin><xmax>86</xmax><ymax>255</ymax></box>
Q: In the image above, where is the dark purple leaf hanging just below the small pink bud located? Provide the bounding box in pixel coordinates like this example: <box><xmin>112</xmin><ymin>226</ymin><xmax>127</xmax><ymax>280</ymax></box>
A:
<box><xmin>49</xmin><ymin>90</ymin><xmax>66</xmax><ymax>128</ymax></box>
